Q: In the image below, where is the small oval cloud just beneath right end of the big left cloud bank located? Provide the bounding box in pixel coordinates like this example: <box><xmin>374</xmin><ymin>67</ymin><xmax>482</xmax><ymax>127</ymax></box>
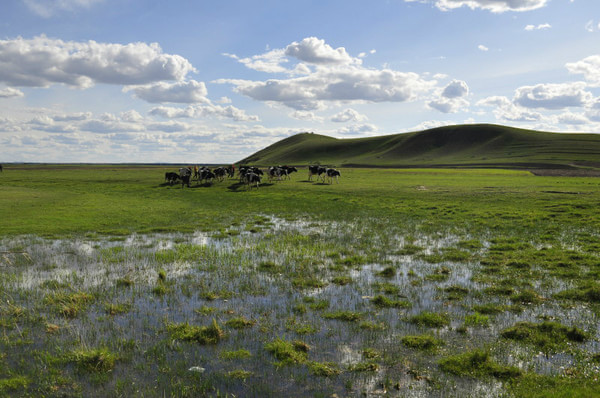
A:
<box><xmin>123</xmin><ymin>80</ymin><xmax>208</xmax><ymax>104</ymax></box>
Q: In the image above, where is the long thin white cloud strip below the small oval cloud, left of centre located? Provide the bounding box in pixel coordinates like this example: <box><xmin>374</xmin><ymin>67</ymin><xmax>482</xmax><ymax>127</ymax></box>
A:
<box><xmin>150</xmin><ymin>103</ymin><xmax>260</xmax><ymax>122</ymax></box>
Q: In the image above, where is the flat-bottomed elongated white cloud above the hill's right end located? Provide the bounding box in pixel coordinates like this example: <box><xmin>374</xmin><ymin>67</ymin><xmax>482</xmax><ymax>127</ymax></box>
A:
<box><xmin>514</xmin><ymin>82</ymin><xmax>593</xmax><ymax>110</ymax></box>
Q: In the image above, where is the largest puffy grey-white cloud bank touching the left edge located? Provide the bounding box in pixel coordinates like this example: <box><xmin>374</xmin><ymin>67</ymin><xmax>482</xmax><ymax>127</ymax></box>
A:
<box><xmin>0</xmin><ymin>36</ymin><xmax>195</xmax><ymax>88</ymax></box>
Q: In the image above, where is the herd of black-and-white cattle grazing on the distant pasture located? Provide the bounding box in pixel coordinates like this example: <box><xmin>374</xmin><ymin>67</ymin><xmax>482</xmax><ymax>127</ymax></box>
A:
<box><xmin>165</xmin><ymin>165</ymin><xmax>340</xmax><ymax>188</ymax></box>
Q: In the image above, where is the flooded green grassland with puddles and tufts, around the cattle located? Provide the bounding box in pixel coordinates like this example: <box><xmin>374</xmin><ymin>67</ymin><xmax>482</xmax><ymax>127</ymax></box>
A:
<box><xmin>0</xmin><ymin>166</ymin><xmax>600</xmax><ymax>397</ymax></box>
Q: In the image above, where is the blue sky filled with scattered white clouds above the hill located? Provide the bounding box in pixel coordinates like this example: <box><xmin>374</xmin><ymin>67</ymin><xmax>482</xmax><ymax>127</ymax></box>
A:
<box><xmin>0</xmin><ymin>0</ymin><xmax>600</xmax><ymax>164</ymax></box>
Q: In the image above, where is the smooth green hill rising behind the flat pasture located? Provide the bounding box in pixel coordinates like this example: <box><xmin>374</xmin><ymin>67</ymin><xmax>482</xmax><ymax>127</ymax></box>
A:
<box><xmin>238</xmin><ymin>124</ymin><xmax>600</xmax><ymax>169</ymax></box>
